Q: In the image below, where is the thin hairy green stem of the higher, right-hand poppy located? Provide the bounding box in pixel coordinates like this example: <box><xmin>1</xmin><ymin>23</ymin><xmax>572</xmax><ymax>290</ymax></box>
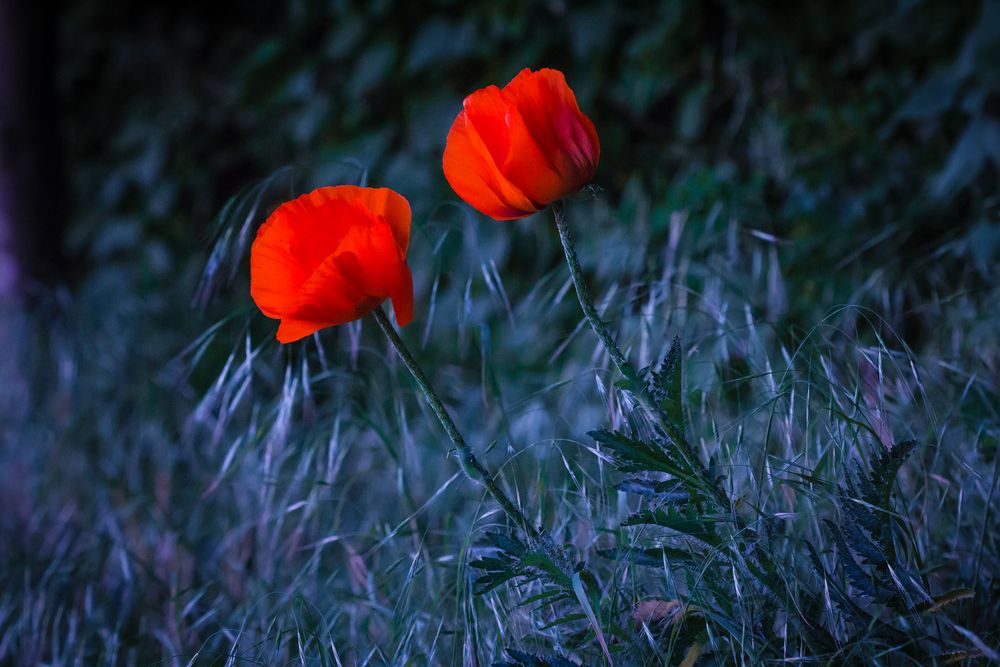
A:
<box><xmin>552</xmin><ymin>201</ymin><xmax>729</xmax><ymax>508</ymax></box>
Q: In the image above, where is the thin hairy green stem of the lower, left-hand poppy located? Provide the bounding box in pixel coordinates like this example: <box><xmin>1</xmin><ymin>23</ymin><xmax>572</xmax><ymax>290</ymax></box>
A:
<box><xmin>372</xmin><ymin>306</ymin><xmax>539</xmax><ymax>538</ymax></box>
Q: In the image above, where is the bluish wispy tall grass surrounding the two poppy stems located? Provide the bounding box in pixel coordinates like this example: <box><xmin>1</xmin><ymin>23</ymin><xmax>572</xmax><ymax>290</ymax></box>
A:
<box><xmin>0</xmin><ymin>175</ymin><xmax>1000</xmax><ymax>665</ymax></box>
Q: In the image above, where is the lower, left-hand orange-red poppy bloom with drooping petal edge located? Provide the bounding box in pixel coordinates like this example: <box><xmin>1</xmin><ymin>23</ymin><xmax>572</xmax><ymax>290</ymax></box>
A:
<box><xmin>250</xmin><ymin>185</ymin><xmax>413</xmax><ymax>343</ymax></box>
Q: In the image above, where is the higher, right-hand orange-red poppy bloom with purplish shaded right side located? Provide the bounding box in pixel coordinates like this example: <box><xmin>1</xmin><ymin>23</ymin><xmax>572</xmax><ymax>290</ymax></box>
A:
<box><xmin>444</xmin><ymin>69</ymin><xmax>601</xmax><ymax>220</ymax></box>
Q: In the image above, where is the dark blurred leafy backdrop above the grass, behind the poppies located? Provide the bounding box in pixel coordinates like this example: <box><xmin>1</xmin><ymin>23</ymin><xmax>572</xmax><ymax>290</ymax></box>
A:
<box><xmin>3</xmin><ymin>0</ymin><xmax>1000</xmax><ymax>307</ymax></box>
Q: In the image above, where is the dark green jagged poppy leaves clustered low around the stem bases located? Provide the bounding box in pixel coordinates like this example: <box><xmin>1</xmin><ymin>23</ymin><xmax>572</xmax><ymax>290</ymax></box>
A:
<box><xmin>472</xmin><ymin>338</ymin><xmax>976</xmax><ymax>664</ymax></box>
